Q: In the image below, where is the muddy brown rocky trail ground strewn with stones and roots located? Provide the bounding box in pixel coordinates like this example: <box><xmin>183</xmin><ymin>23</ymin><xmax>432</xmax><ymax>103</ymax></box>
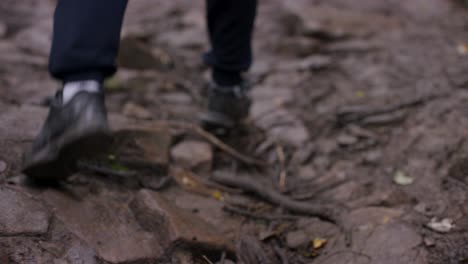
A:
<box><xmin>0</xmin><ymin>0</ymin><xmax>468</xmax><ymax>264</ymax></box>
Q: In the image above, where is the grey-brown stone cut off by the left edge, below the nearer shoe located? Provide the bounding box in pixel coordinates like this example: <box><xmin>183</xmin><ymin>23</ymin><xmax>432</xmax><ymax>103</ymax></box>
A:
<box><xmin>0</xmin><ymin>188</ymin><xmax>50</xmax><ymax>235</ymax></box>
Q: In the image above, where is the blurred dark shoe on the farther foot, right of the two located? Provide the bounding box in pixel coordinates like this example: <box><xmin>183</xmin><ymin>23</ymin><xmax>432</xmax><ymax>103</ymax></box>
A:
<box><xmin>200</xmin><ymin>83</ymin><xmax>252</xmax><ymax>133</ymax></box>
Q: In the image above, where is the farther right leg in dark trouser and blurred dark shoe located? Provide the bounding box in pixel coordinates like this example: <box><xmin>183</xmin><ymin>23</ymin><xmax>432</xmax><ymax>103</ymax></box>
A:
<box><xmin>201</xmin><ymin>0</ymin><xmax>257</xmax><ymax>133</ymax></box>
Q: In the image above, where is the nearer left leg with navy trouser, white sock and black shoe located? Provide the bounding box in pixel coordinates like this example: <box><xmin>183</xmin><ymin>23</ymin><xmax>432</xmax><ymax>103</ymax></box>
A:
<box><xmin>23</xmin><ymin>0</ymin><xmax>127</xmax><ymax>180</ymax></box>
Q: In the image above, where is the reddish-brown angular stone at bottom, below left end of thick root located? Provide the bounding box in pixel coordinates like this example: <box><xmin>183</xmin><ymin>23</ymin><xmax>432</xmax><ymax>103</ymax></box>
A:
<box><xmin>130</xmin><ymin>190</ymin><xmax>233</xmax><ymax>253</ymax></box>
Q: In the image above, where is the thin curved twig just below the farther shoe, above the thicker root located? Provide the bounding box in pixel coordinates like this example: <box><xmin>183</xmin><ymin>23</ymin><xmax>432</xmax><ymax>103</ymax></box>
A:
<box><xmin>172</xmin><ymin>122</ymin><xmax>267</xmax><ymax>166</ymax></box>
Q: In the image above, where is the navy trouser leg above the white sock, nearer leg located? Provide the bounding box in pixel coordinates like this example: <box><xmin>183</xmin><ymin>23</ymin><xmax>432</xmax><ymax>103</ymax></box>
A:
<box><xmin>49</xmin><ymin>0</ymin><xmax>127</xmax><ymax>81</ymax></box>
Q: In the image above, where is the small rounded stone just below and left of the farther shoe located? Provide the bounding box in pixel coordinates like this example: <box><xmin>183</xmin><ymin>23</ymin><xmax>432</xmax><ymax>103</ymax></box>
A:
<box><xmin>171</xmin><ymin>140</ymin><xmax>213</xmax><ymax>172</ymax></box>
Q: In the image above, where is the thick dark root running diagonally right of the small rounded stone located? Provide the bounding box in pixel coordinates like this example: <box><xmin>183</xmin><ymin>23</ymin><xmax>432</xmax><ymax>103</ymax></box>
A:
<box><xmin>212</xmin><ymin>173</ymin><xmax>343</xmax><ymax>226</ymax></box>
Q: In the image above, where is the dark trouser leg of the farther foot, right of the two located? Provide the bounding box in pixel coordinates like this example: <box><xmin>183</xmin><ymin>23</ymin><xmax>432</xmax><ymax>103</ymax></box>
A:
<box><xmin>205</xmin><ymin>0</ymin><xmax>257</xmax><ymax>85</ymax></box>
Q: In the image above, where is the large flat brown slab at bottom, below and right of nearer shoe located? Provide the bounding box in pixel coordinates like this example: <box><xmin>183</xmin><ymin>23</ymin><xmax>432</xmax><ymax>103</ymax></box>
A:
<box><xmin>43</xmin><ymin>190</ymin><xmax>164</xmax><ymax>263</ymax></box>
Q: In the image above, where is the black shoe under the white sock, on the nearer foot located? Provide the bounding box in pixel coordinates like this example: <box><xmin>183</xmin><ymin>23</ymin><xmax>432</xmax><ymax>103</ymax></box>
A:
<box><xmin>23</xmin><ymin>82</ymin><xmax>110</xmax><ymax>180</ymax></box>
